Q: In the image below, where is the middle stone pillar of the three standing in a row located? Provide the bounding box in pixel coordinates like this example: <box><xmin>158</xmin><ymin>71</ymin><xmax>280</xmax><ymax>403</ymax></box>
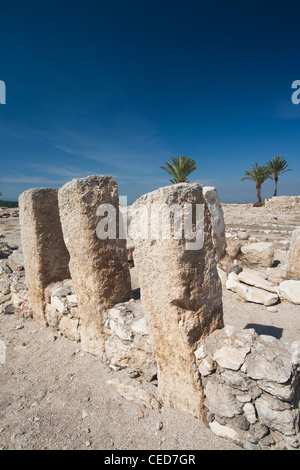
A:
<box><xmin>58</xmin><ymin>175</ymin><xmax>131</xmax><ymax>354</ymax></box>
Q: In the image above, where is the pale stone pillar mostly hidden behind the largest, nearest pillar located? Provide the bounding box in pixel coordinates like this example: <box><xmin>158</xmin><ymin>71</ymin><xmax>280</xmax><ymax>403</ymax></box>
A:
<box><xmin>203</xmin><ymin>186</ymin><xmax>226</xmax><ymax>261</ymax></box>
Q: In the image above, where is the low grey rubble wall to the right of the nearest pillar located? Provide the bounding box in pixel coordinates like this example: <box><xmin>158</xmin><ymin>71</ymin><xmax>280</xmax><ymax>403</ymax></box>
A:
<box><xmin>195</xmin><ymin>326</ymin><xmax>300</xmax><ymax>449</ymax></box>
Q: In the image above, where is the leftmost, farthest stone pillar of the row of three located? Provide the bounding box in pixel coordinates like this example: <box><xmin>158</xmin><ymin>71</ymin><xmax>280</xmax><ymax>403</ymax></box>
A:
<box><xmin>19</xmin><ymin>188</ymin><xmax>70</xmax><ymax>324</ymax></box>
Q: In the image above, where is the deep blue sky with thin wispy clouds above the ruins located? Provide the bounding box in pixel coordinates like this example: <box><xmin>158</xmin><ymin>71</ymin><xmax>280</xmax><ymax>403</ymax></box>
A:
<box><xmin>0</xmin><ymin>0</ymin><xmax>300</xmax><ymax>203</ymax></box>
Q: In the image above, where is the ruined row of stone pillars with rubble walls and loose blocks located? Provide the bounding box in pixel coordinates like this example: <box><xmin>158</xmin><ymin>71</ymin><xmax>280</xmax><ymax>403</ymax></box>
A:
<box><xmin>0</xmin><ymin>175</ymin><xmax>300</xmax><ymax>449</ymax></box>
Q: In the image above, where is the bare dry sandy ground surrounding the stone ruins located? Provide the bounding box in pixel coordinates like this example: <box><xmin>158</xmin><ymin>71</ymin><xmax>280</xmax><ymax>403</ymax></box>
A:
<box><xmin>0</xmin><ymin>205</ymin><xmax>300</xmax><ymax>451</ymax></box>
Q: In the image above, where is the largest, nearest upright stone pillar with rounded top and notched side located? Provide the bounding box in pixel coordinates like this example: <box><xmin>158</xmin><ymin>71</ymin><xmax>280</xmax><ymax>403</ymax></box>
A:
<box><xmin>132</xmin><ymin>183</ymin><xmax>223</xmax><ymax>418</ymax></box>
